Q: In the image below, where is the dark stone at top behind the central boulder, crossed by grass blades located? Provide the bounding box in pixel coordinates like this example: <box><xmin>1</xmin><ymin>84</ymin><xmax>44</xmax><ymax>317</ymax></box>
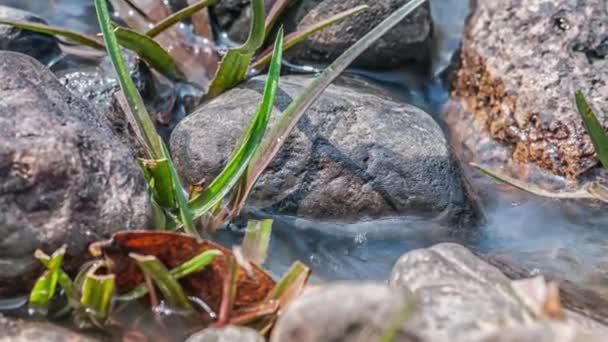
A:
<box><xmin>284</xmin><ymin>0</ymin><xmax>432</xmax><ymax>69</ymax></box>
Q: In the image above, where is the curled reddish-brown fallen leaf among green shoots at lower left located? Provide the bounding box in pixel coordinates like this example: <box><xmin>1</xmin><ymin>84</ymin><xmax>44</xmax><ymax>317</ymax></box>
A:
<box><xmin>90</xmin><ymin>231</ymin><xmax>275</xmax><ymax>315</ymax></box>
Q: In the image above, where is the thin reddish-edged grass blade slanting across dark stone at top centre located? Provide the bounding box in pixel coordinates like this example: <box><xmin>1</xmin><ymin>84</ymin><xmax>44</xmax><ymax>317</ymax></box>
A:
<box><xmin>251</xmin><ymin>5</ymin><xmax>368</xmax><ymax>70</ymax></box>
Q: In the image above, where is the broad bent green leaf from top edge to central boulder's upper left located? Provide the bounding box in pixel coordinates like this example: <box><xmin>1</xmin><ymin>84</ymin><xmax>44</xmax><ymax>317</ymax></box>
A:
<box><xmin>207</xmin><ymin>0</ymin><xmax>265</xmax><ymax>97</ymax></box>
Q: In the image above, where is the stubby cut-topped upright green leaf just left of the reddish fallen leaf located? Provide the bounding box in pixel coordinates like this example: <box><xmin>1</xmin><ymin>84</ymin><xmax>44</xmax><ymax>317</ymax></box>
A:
<box><xmin>80</xmin><ymin>267</ymin><xmax>115</xmax><ymax>325</ymax></box>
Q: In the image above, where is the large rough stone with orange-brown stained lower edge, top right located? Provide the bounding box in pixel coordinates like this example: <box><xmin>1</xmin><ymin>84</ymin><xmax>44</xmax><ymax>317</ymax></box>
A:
<box><xmin>452</xmin><ymin>0</ymin><xmax>608</xmax><ymax>179</ymax></box>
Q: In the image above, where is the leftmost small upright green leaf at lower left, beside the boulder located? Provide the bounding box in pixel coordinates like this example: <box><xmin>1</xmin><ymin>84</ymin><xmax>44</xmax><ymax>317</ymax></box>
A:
<box><xmin>29</xmin><ymin>246</ymin><xmax>66</xmax><ymax>316</ymax></box>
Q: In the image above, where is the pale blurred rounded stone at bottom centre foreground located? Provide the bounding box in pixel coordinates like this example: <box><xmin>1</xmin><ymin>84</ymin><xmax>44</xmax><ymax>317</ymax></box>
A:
<box><xmin>270</xmin><ymin>283</ymin><xmax>421</xmax><ymax>342</ymax></box>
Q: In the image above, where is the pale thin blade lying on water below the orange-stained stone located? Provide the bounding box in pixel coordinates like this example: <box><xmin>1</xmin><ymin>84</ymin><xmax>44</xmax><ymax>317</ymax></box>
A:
<box><xmin>471</xmin><ymin>163</ymin><xmax>608</xmax><ymax>203</ymax></box>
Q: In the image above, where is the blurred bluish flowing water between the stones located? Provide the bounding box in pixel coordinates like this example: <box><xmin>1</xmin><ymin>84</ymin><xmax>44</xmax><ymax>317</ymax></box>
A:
<box><xmin>0</xmin><ymin>0</ymin><xmax>608</xmax><ymax>298</ymax></box>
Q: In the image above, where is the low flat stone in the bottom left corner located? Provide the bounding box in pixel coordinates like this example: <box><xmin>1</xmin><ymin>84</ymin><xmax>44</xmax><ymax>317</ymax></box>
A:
<box><xmin>0</xmin><ymin>314</ymin><xmax>101</xmax><ymax>342</ymax></box>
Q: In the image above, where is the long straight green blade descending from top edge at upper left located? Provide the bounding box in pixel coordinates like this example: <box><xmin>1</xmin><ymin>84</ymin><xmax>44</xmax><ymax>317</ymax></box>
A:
<box><xmin>95</xmin><ymin>0</ymin><xmax>164</xmax><ymax>159</ymax></box>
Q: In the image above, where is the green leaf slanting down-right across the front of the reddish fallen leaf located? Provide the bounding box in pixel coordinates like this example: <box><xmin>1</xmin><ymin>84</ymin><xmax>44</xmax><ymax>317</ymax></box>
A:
<box><xmin>129</xmin><ymin>253</ymin><xmax>196</xmax><ymax>316</ymax></box>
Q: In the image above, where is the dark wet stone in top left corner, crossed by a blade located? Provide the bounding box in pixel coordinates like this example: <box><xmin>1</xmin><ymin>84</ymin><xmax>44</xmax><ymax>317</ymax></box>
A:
<box><xmin>0</xmin><ymin>5</ymin><xmax>61</xmax><ymax>63</ymax></box>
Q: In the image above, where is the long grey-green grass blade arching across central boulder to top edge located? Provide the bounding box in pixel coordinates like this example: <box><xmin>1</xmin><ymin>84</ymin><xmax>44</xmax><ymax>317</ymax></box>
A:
<box><xmin>235</xmin><ymin>0</ymin><xmax>426</xmax><ymax>211</ymax></box>
